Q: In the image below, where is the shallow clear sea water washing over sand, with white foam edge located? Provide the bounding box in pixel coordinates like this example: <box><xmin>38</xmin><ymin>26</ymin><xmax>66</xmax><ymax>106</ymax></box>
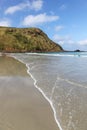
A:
<box><xmin>11</xmin><ymin>52</ymin><xmax>87</xmax><ymax>130</ymax></box>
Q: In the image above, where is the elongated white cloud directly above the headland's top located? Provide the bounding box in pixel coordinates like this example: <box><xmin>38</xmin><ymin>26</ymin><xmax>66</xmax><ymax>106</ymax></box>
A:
<box><xmin>22</xmin><ymin>13</ymin><xmax>59</xmax><ymax>26</ymax></box>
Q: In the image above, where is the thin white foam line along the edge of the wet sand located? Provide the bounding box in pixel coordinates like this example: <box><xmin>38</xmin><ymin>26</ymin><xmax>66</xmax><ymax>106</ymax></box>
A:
<box><xmin>10</xmin><ymin>55</ymin><xmax>63</xmax><ymax>130</ymax></box>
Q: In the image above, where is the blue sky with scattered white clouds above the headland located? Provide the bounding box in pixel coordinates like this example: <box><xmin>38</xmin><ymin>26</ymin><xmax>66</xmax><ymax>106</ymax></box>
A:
<box><xmin>0</xmin><ymin>0</ymin><xmax>87</xmax><ymax>51</ymax></box>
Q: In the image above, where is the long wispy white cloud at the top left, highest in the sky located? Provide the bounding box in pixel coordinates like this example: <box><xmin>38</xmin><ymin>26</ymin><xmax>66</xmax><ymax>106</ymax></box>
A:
<box><xmin>5</xmin><ymin>0</ymin><xmax>43</xmax><ymax>14</ymax></box>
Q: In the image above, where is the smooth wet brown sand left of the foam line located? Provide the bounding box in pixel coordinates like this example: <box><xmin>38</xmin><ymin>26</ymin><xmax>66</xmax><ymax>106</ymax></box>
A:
<box><xmin>0</xmin><ymin>56</ymin><xmax>59</xmax><ymax>130</ymax></box>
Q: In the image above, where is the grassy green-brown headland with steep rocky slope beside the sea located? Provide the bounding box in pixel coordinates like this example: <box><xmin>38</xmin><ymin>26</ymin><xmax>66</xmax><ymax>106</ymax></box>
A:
<box><xmin>0</xmin><ymin>27</ymin><xmax>63</xmax><ymax>52</ymax></box>
